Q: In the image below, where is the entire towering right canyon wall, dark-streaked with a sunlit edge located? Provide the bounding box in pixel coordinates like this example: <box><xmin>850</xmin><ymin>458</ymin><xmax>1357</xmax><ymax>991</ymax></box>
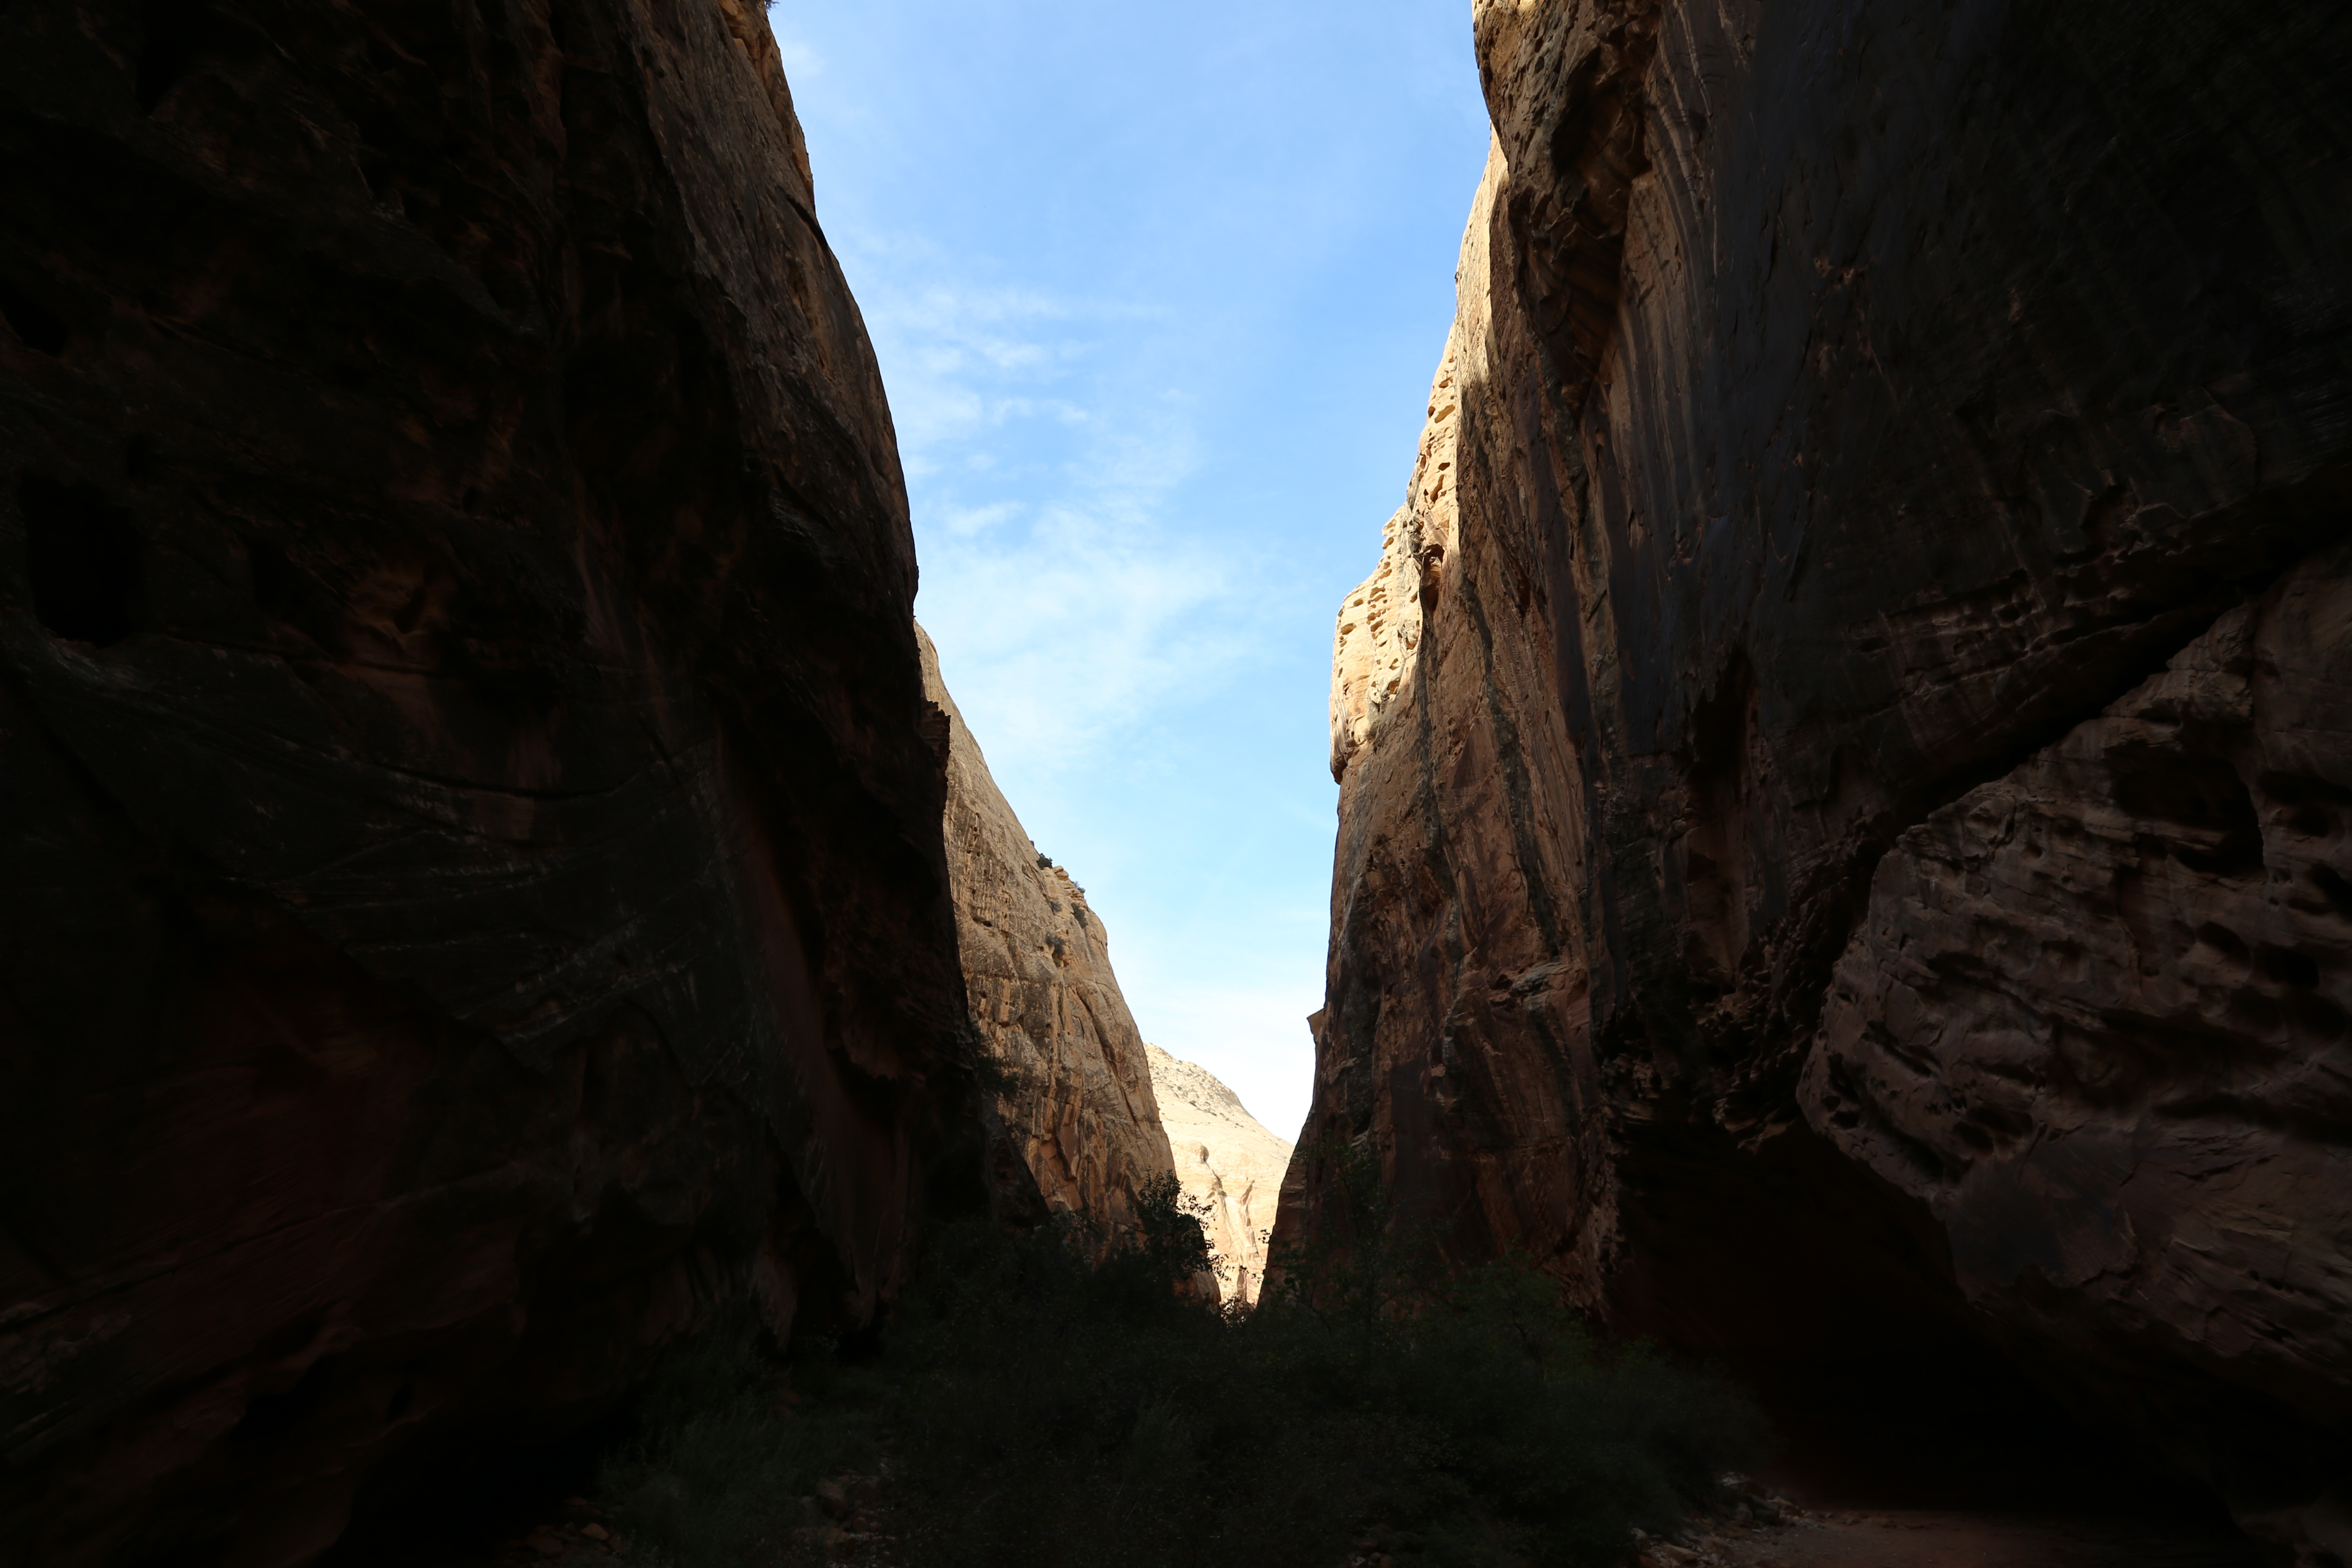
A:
<box><xmin>1277</xmin><ymin>0</ymin><xmax>2352</xmax><ymax>1552</ymax></box>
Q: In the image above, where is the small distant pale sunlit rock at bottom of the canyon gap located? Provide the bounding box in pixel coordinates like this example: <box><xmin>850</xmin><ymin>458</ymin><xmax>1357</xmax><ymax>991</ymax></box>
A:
<box><xmin>1143</xmin><ymin>1044</ymin><xmax>1291</xmax><ymax>1307</ymax></box>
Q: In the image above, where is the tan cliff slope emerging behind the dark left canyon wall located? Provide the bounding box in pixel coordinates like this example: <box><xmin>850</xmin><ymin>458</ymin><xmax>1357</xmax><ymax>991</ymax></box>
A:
<box><xmin>915</xmin><ymin>628</ymin><xmax>1174</xmax><ymax>1234</ymax></box>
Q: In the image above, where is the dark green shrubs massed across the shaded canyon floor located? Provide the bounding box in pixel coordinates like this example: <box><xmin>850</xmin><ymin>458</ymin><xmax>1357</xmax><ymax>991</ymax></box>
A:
<box><xmin>607</xmin><ymin>1182</ymin><xmax>1762</xmax><ymax>1568</ymax></box>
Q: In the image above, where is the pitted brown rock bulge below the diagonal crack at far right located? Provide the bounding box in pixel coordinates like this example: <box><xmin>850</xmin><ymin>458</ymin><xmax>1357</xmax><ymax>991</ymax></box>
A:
<box><xmin>1799</xmin><ymin>548</ymin><xmax>2352</xmax><ymax>1554</ymax></box>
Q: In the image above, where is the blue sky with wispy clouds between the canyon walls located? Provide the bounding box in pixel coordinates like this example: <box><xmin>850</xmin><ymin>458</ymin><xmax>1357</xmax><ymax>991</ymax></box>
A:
<box><xmin>769</xmin><ymin>0</ymin><xmax>1486</xmax><ymax>1136</ymax></box>
